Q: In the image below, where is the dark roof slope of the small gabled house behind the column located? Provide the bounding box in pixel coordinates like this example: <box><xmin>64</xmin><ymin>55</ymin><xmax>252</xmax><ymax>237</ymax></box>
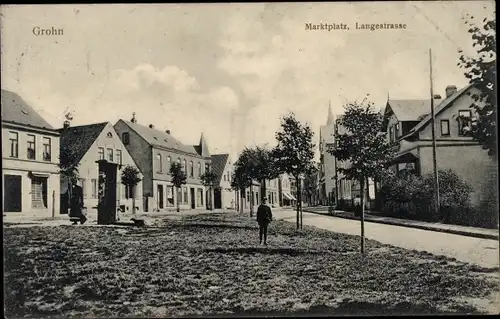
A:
<box><xmin>58</xmin><ymin>122</ymin><xmax>108</xmax><ymax>164</ymax></box>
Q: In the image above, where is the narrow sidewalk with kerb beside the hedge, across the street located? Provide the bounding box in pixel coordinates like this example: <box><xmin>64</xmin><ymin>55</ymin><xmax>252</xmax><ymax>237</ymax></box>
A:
<box><xmin>303</xmin><ymin>207</ymin><xmax>498</xmax><ymax>240</ymax></box>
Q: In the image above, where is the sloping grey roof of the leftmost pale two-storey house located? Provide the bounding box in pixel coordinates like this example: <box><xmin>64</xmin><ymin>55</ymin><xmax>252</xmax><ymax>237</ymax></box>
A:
<box><xmin>1</xmin><ymin>90</ymin><xmax>55</xmax><ymax>131</ymax></box>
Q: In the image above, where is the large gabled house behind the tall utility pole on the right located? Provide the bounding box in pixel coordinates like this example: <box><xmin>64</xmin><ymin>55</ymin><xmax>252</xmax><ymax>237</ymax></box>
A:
<box><xmin>382</xmin><ymin>85</ymin><xmax>498</xmax><ymax>204</ymax></box>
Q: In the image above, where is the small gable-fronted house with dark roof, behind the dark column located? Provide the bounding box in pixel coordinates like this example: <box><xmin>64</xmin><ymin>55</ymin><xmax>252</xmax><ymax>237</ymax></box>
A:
<box><xmin>58</xmin><ymin>121</ymin><xmax>142</xmax><ymax>218</ymax></box>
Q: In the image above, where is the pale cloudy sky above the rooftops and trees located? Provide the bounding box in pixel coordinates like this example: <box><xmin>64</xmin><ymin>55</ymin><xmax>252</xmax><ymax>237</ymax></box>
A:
<box><xmin>1</xmin><ymin>1</ymin><xmax>495</xmax><ymax>161</ymax></box>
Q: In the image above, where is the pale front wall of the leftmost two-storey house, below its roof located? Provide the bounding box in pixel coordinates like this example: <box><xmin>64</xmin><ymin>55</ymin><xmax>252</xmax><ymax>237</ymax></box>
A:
<box><xmin>2</xmin><ymin>124</ymin><xmax>60</xmax><ymax>217</ymax></box>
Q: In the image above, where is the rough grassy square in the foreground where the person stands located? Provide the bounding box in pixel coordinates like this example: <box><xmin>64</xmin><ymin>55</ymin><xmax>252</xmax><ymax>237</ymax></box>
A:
<box><xmin>4</xmin><ymin>213</ymin><xmax>499</xmax><ymax>317</ymax></box>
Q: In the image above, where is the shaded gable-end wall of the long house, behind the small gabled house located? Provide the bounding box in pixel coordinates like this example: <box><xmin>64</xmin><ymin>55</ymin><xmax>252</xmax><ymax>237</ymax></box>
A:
<box><xmin>113</xmin><ymin>120</ymin><xmax>153</xmax><ymax>198</ymax></box>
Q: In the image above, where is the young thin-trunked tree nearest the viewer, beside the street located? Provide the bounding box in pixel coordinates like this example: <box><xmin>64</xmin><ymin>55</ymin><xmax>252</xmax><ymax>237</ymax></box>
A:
<box><xmin>327</xmin><ymin>98</ymin><xmax>397</xmax><ymax>254</ymax></box>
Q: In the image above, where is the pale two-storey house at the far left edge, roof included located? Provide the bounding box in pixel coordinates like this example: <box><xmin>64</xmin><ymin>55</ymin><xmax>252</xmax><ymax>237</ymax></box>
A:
<box><xmin>1</xmin><ymin>90</ymin><xmax>59</xmax><ymax>217</ymax></box>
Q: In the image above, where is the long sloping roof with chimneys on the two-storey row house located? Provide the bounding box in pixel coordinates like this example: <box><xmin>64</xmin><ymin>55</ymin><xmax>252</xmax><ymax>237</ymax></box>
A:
<box><xmin>120</xmin><ymin>120</ymin><xmax>200</xmax><ymax>155</ymax></box>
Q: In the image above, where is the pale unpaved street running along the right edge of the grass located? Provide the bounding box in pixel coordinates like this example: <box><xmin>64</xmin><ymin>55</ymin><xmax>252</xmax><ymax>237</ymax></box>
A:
<box><xmin>273</xmin><ymin>209</ymin><xmax>499</xmax><ymax>267</ymax></box>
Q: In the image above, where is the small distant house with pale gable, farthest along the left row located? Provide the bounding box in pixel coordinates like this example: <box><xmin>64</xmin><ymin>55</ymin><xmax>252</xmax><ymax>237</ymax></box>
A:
<box><xmin>211</xmin><ymin>154</ymin><xmax>236</xmax><ymax>209</ymax></box>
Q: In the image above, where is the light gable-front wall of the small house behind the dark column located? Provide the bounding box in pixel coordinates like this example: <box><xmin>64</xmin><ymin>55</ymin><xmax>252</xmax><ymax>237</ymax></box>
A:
<box><xmin>78</xmin><ymin>123</ymin><xmax>143</xmax><ymax>214</ymax></box>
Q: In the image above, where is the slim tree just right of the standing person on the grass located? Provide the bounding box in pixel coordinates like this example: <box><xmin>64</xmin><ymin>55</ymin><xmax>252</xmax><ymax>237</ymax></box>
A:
<box><xmin>272</xmin><ymin>113</ymin><xmax>316</xmax><ymax>229</ymax></box>
